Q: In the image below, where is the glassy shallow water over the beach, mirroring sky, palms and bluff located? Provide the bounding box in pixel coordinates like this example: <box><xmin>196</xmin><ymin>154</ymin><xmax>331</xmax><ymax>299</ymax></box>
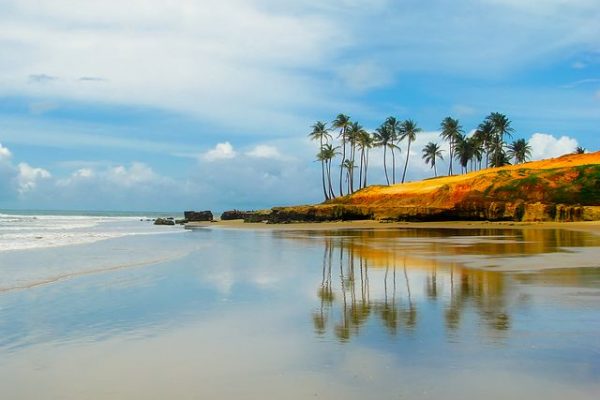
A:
<box><xmin>0</xmin><ymin>229</ymin><xmax>600</xmax><ymax>399</ymax></box>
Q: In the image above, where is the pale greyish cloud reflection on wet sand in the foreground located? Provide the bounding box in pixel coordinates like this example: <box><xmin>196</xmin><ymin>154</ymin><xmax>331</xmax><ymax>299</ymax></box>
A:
<box><xmin>0</xmin><ymin>307</ymin><xmax>600</xmax><ymax>400</ymax></box>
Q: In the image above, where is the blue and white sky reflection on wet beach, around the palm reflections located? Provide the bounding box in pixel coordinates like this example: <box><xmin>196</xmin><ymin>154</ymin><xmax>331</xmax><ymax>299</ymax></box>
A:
<box><xmin>0</xmin><ymin>230</ymin><xmax>600</xmax><ymax>398</ymax></box>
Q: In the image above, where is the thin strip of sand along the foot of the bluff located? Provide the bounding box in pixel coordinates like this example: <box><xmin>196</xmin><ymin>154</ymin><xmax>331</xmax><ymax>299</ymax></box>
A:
<box><xmin>185</xmin><ymin>219</ymin><xmax>600</xmax><ymax>235</ymax></box>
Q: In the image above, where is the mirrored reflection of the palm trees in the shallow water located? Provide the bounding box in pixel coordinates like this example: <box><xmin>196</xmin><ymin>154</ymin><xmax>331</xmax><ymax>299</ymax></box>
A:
<box><xmin>313</xmin><ymin>236</ymin><xmax>510</xmax><ymax>342</ymax></box>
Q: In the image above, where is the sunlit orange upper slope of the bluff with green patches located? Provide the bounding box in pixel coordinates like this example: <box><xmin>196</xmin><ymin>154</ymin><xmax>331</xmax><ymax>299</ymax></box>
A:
<box><xmin>330</xmin><ymin>152</ymin><xmax>600</xmax><ymax>206</ymax></box>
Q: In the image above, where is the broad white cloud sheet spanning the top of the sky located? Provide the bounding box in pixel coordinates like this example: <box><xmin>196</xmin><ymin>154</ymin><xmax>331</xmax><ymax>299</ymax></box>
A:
<box><xmin>0</xmin><ymin>0</ymin><xmax>600</xmax><ymax>133</ymax></box>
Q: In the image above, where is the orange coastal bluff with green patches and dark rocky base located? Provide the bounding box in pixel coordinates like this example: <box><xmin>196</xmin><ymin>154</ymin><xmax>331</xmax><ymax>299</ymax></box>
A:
<box><xmin>260</xmin><ymin>152</ymin><xmax>600</xmax><ymax>223</ymax></box>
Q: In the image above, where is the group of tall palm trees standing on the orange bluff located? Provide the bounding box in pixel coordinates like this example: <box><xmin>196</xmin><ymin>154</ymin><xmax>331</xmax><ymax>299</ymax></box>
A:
<box><xmin>309</xmin><ymin>112</ymin><xmax>531</xmax><ymax>200</ymax></box>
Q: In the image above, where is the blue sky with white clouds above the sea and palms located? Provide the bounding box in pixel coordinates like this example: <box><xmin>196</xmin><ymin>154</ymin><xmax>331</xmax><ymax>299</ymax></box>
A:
<box><xmin>0</xmin><ymin>0</ymin><xmax>600</xmax><ymax>211</ymax></box>
